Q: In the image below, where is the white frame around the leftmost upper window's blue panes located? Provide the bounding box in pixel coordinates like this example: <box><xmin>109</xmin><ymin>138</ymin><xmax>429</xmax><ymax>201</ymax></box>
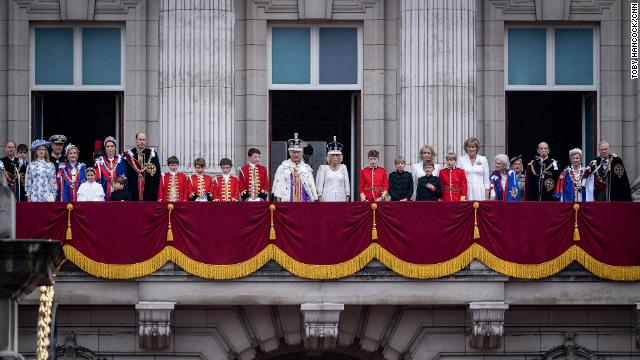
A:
<box><xmin>29</xmin><ymin>23</ymin><xmax>126</xmax><ymax>91</ymax></box>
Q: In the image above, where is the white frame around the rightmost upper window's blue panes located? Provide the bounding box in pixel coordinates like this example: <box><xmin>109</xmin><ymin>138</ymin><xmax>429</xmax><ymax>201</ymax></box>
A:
<box><xmin>504</xmin><ymin>24</ymin><xmax>600</xmax><ymax>91</ymax></box>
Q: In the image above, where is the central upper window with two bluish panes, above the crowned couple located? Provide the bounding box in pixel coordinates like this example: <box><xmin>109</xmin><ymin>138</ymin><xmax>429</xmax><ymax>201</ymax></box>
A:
<box><xmin>268</xmin><ymin>25</ymin><xmax>362</xmax><ymax>90</ymax></box>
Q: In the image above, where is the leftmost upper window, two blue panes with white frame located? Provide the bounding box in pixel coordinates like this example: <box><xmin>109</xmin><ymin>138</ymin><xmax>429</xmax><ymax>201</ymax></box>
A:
<box><xmin>31</xmin><ymin>25</ymin><xmax>124</xmax><ymax>90</ymax></box>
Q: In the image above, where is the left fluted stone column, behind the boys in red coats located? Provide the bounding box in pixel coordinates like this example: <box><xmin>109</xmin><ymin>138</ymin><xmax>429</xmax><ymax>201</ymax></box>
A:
<box><xmin>159</xmin><ymin>0</ymin><xmax>235</xmax><ymax>170</ymax></box>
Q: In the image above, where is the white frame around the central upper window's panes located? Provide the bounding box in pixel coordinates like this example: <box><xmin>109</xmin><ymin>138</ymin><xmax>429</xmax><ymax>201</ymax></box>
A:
<box><xmin>267</xmin><ymin>22</ymin><xmax>363</xmax><ymax>90</ymax></box>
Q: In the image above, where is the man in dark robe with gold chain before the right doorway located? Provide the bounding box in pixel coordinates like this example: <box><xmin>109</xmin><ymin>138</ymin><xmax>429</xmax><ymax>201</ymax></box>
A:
<box><xmin>524</xmin><ymin>141</ymin><xmax>561</xmax><ymax>201</ymax></box>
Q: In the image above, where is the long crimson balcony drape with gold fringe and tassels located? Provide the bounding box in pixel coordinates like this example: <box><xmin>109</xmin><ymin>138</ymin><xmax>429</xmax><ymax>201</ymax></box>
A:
<box><xmin>17</xmin><ymin>202</ymin><xmax>640</xmax><ymax>281</ymax></box>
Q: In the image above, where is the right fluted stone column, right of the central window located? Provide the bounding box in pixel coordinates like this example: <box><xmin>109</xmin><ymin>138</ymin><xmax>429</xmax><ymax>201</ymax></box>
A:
<box><xmin>400</xmin><ymin>0</ymin><xmax>476</xmax><ymax>163</ymax></box>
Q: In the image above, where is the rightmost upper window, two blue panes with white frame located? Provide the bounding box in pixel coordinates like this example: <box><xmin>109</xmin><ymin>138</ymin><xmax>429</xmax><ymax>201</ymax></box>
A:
<box><xmin>505</xmin><ymin>26</ymin><xmax>598</xmax><ymax>90</ymax></box>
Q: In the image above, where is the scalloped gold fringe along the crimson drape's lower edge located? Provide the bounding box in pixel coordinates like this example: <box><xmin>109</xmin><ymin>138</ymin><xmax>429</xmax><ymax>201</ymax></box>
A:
<box><xmin>64</xmin><ymin>243</ymin><xmax>640</xmax><ymax>281</ymax></box>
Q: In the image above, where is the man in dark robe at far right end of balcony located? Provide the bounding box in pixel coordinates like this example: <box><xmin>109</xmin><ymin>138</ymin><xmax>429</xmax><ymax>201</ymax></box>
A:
<box><xmin>585</xmin><ymin>141</ymin><xmax>631</xmax><ymax>201</ymax></box>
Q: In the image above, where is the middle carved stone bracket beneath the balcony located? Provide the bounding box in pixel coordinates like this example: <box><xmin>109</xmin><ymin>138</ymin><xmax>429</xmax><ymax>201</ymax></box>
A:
<box><xmin>300</xmin><ymin>303</ymin><xmax>344</xmax><ymax>351</ymax></box>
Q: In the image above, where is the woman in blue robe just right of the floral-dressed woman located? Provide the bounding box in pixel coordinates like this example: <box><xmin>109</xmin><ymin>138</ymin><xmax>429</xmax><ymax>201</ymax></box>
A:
<box><xmin>56</xmin><ymin>144</ymin><xmax>87</xmax><ymax>202</ymax></box>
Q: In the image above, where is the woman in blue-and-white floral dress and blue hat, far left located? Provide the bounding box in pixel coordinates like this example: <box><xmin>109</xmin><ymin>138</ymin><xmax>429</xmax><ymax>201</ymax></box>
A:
<box><xmin>24</xmin><ymin>140</ymin><xmax>56</xmax><ymax>202</ymax></box>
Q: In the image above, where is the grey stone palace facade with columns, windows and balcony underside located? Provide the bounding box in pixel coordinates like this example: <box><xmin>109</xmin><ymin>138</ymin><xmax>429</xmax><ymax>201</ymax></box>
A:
<box><xmin>5</xmin><ymin>0</ymin><xmax>640</xmax><ymax>360</ymax></box>
